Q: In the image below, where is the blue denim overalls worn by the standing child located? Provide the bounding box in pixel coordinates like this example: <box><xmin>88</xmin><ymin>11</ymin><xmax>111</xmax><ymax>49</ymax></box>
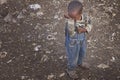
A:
<box><xmin>65</xmin><ymin>13</ymin><xmax>90</xmax><ymax>70</ymax></box>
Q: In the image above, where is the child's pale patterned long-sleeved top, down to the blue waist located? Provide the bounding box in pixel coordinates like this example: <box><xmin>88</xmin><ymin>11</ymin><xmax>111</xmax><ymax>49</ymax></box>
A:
<box><xmin>65</xmin><ymin>14</ymin><xmax>92</xmax><ymax>40</ymax></box>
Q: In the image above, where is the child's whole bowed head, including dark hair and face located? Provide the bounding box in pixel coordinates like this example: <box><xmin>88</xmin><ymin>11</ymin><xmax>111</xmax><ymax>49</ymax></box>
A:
<box><xmin>68</xmin><ymin>0</ymin><xmax>83</xmax><ymax>20</ymax></box>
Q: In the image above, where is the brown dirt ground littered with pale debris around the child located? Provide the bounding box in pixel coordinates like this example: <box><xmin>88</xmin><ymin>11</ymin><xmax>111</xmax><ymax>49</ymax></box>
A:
<box><xmin>0</xmin><ymin>0</ymin><xmax>120</xmax><ymax>80</ymax></box>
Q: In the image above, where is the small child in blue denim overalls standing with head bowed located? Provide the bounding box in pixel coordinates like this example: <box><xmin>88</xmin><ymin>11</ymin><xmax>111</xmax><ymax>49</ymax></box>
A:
<box><xmin>65</xmin><ymin>0</ymin><xmax>92</xmax><ymax>79</ymax></box>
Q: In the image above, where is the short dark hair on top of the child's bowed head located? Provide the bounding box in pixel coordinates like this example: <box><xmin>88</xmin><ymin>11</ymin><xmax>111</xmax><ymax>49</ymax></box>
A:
<box><xmin>68</xmin><ymin>0</ymin><xmax>83</xmax><ymax>14</ymax></box>
